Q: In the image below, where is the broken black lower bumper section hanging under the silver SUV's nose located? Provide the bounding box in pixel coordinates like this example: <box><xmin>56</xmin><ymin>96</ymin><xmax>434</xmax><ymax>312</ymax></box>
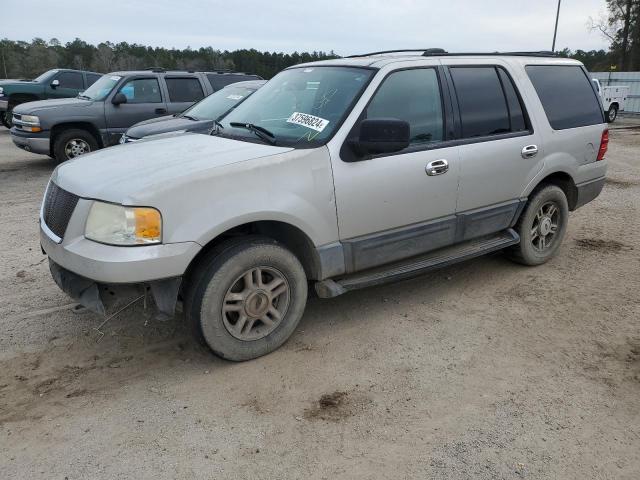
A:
<box><xmin>49</xmin><ymin>259</ymin><xmax>182</xmax><ymax>320</ymax></box>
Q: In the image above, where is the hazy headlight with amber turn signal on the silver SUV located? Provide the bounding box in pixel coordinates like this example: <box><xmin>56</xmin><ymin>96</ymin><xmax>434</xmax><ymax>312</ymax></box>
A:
<box><xmin>84</xmin><ymin>201</ymin><xmax>162</xmax><ymax>245</ymax></box>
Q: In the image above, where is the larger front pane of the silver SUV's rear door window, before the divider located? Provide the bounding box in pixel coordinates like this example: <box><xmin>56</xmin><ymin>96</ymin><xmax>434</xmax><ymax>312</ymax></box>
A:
<box><xmin>450</xmin><ymin>67</ymin><xmax>511</xmax><ymax>138</ymax></box>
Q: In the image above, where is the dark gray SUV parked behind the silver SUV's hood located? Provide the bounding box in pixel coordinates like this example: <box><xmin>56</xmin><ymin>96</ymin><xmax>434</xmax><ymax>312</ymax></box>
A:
<box><xmin>11</xmin><ymin>69</ymin><xmax>261</xmax><ymax>162</ymax></box>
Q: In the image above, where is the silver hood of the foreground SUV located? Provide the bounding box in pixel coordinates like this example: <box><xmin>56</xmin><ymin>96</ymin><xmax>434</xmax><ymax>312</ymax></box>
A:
<box><xmin>51</xmin><ymin>134</ymin><xmax>293</xmax><ymax>205</ymax></box>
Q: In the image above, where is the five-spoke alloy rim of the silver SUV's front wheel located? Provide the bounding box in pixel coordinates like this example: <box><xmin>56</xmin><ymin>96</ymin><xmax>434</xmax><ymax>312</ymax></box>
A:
<box><xmin>222</xmin><ymin>266</ymin><xmax>291</xmax><ymax>341</ymax></box>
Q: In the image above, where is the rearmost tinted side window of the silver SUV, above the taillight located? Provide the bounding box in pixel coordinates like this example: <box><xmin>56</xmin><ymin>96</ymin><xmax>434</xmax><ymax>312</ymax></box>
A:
<box><xmin>525</xmin><ymin>65</ymin><xmax>604</xmax><ymax>130</ymax></box>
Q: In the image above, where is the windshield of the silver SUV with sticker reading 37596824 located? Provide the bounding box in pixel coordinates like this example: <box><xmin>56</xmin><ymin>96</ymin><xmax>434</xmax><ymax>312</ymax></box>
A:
<box><xmin>220</xmin><ymin>67</ymin><xmax>374</xmax><ymax>148</ymax></box>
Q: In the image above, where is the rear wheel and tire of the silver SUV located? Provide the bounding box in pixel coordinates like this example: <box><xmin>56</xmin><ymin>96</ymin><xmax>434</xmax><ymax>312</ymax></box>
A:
<box><xmin>507</xmin><ymin>185</ymin><xmax>569</xmax><ymax>265</ymax></box>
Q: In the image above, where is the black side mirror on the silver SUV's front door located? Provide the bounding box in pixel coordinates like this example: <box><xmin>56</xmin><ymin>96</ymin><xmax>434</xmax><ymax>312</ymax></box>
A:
<box><xmin>349</xmin><ymin>118</ymin><xmax>410</xmax><ymax>156</ymax></box>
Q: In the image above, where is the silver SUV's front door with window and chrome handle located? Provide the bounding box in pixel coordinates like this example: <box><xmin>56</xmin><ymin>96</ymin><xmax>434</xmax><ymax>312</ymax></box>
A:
<box><xmin>332</xmin><ymin>65</ymin><xmax>459</xmax><ymax>271</ymax></box>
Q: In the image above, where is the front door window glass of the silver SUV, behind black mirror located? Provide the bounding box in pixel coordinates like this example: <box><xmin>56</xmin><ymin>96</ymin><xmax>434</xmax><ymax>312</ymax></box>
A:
<box><xmin>365</xmin><ymin>68</ymin><xmax>444</xmax><ymax>145</ymax></box>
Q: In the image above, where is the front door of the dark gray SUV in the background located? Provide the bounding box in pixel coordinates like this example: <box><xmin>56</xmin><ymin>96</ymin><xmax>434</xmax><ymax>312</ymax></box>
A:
<box><xmin>105</xmin><ymin>76</ymin><xmax>167</xmax><ymax>140</ymax></box>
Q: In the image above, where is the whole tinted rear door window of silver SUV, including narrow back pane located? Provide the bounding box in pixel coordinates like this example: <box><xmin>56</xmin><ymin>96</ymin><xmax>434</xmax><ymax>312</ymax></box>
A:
<box><xmin>450</xmin><ymin>66</ymin><xmax>527</xmax><ymax>138</ymax></box>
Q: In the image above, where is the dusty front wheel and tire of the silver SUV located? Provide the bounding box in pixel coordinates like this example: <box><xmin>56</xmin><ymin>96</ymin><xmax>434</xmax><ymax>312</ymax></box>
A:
<box><xmin>184</xmin><ymin>236</ymin><xmax>307</xmax><ymax>361</ymax></box>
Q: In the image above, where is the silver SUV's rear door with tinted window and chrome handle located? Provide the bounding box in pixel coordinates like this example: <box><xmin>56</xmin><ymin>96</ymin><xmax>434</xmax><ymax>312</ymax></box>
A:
<box><xmin>443</xmin><ymin>59</ymin><xmax>544</xmax><ymax>240</ymax></box>
